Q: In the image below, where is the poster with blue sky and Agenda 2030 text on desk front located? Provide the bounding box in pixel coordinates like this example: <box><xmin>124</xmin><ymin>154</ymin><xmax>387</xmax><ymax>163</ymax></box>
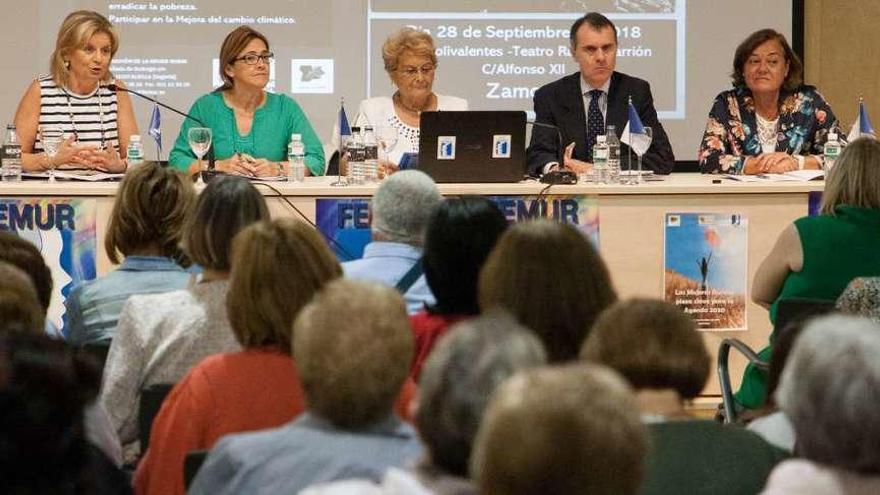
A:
<box><xmin>663</xmin><ymin>213</ymin><xmax>748</xmax><ymax>331</ymax></box>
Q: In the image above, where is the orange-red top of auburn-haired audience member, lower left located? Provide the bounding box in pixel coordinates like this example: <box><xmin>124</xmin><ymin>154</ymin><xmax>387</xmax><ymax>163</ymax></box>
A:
<box><xmin>133</xmin><ymin>348</ymin><xmax>416</xmax><ymax>495</ymax></box>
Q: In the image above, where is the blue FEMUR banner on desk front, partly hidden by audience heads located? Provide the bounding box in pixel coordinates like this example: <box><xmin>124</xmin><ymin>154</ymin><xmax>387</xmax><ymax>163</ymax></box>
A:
<box><xmin>315</xmin><ymin>195</ymin><xmax>599</xmax><ymax>261</ymax></box>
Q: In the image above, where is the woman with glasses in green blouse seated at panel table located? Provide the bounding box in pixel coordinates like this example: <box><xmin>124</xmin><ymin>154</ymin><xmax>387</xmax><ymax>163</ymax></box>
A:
<box><xmin>168</xmin><ymin>26</ymin><xmax>324</xmax><ymax>177</ymax></box>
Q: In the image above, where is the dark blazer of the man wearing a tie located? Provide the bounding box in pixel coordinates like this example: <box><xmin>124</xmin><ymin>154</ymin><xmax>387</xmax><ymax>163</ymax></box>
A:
<box><xmin>526</xmin><ymin>71</ymin><xmax>675</xmax><ymax>176</ymax></box>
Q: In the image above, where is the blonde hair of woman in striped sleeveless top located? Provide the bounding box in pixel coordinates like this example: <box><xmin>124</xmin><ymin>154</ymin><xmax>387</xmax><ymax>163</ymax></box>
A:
<box><xmin>49</xmin><ymin>10</ymin><xmax>119</xmax><ymax>86</ymax></box>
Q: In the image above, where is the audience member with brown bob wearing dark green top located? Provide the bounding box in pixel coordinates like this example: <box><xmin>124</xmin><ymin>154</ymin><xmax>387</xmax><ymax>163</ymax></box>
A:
<box><xmin>581</xmin><ymin>299</ymin><xmax>784</xmax><ymax>495</ymax></box>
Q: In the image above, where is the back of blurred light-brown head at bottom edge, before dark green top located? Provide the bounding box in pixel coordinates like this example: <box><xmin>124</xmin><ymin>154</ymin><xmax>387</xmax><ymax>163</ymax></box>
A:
<box><xmin>471</xmin><ymin>363</ymin><xmax>648</xmax><ymax>495</ymax></box>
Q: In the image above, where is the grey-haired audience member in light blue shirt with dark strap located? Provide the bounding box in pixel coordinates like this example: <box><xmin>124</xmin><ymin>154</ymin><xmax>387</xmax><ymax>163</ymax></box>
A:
<box><xmin>342</xmin><ymin>170</ymin><xmax>443</xmax><ymax>313</ymax></box>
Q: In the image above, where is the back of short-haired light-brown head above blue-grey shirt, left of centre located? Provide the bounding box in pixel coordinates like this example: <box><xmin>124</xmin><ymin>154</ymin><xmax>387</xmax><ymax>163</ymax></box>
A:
<box><xmin>293</xmin><ymin>279</ymin><xmax>413</xmax><ymax>430</ymax></box>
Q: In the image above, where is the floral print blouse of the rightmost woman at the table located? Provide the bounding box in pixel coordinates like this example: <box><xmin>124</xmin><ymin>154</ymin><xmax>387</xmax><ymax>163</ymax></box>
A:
<box><xmin>699</xmin><ymin>85</ymin><xmax>846</xmax><ymax>174</ymax></box>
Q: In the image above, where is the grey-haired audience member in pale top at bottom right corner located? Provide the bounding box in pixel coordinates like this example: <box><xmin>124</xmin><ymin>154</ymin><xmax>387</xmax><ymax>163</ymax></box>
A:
<box><xmin>763</xmin><ymin>315</ymin><xmax>880</xmax><ymax>495</ymax></box>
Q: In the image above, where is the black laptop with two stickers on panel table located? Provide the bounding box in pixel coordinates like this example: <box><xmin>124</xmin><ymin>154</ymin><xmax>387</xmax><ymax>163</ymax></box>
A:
<box><xmin>418</xmin><ymin>111</ymin><xmax>526</xmax><ymax>183</ymax></box>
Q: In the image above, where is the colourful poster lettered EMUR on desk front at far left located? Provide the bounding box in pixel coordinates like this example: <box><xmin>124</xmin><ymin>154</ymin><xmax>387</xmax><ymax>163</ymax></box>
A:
<box><xmin>0</xmin><ymin>198</ymin><xmax>97</xmax><ymax>336</ymax></box>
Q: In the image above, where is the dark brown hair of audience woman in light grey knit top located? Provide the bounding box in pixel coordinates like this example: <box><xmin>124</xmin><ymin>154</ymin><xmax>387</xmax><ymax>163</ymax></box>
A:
<box><xmin>184</xmin><ymin>176</ymin><xmax>269</xmax><ymax>271</ymax></box>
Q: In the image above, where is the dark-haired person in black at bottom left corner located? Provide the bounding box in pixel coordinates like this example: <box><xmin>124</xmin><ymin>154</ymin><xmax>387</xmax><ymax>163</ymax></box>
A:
<box><xmin>0</xmin><ymin>332</ymin><xmax>131</xmax><ymax>494</ymax></box>
